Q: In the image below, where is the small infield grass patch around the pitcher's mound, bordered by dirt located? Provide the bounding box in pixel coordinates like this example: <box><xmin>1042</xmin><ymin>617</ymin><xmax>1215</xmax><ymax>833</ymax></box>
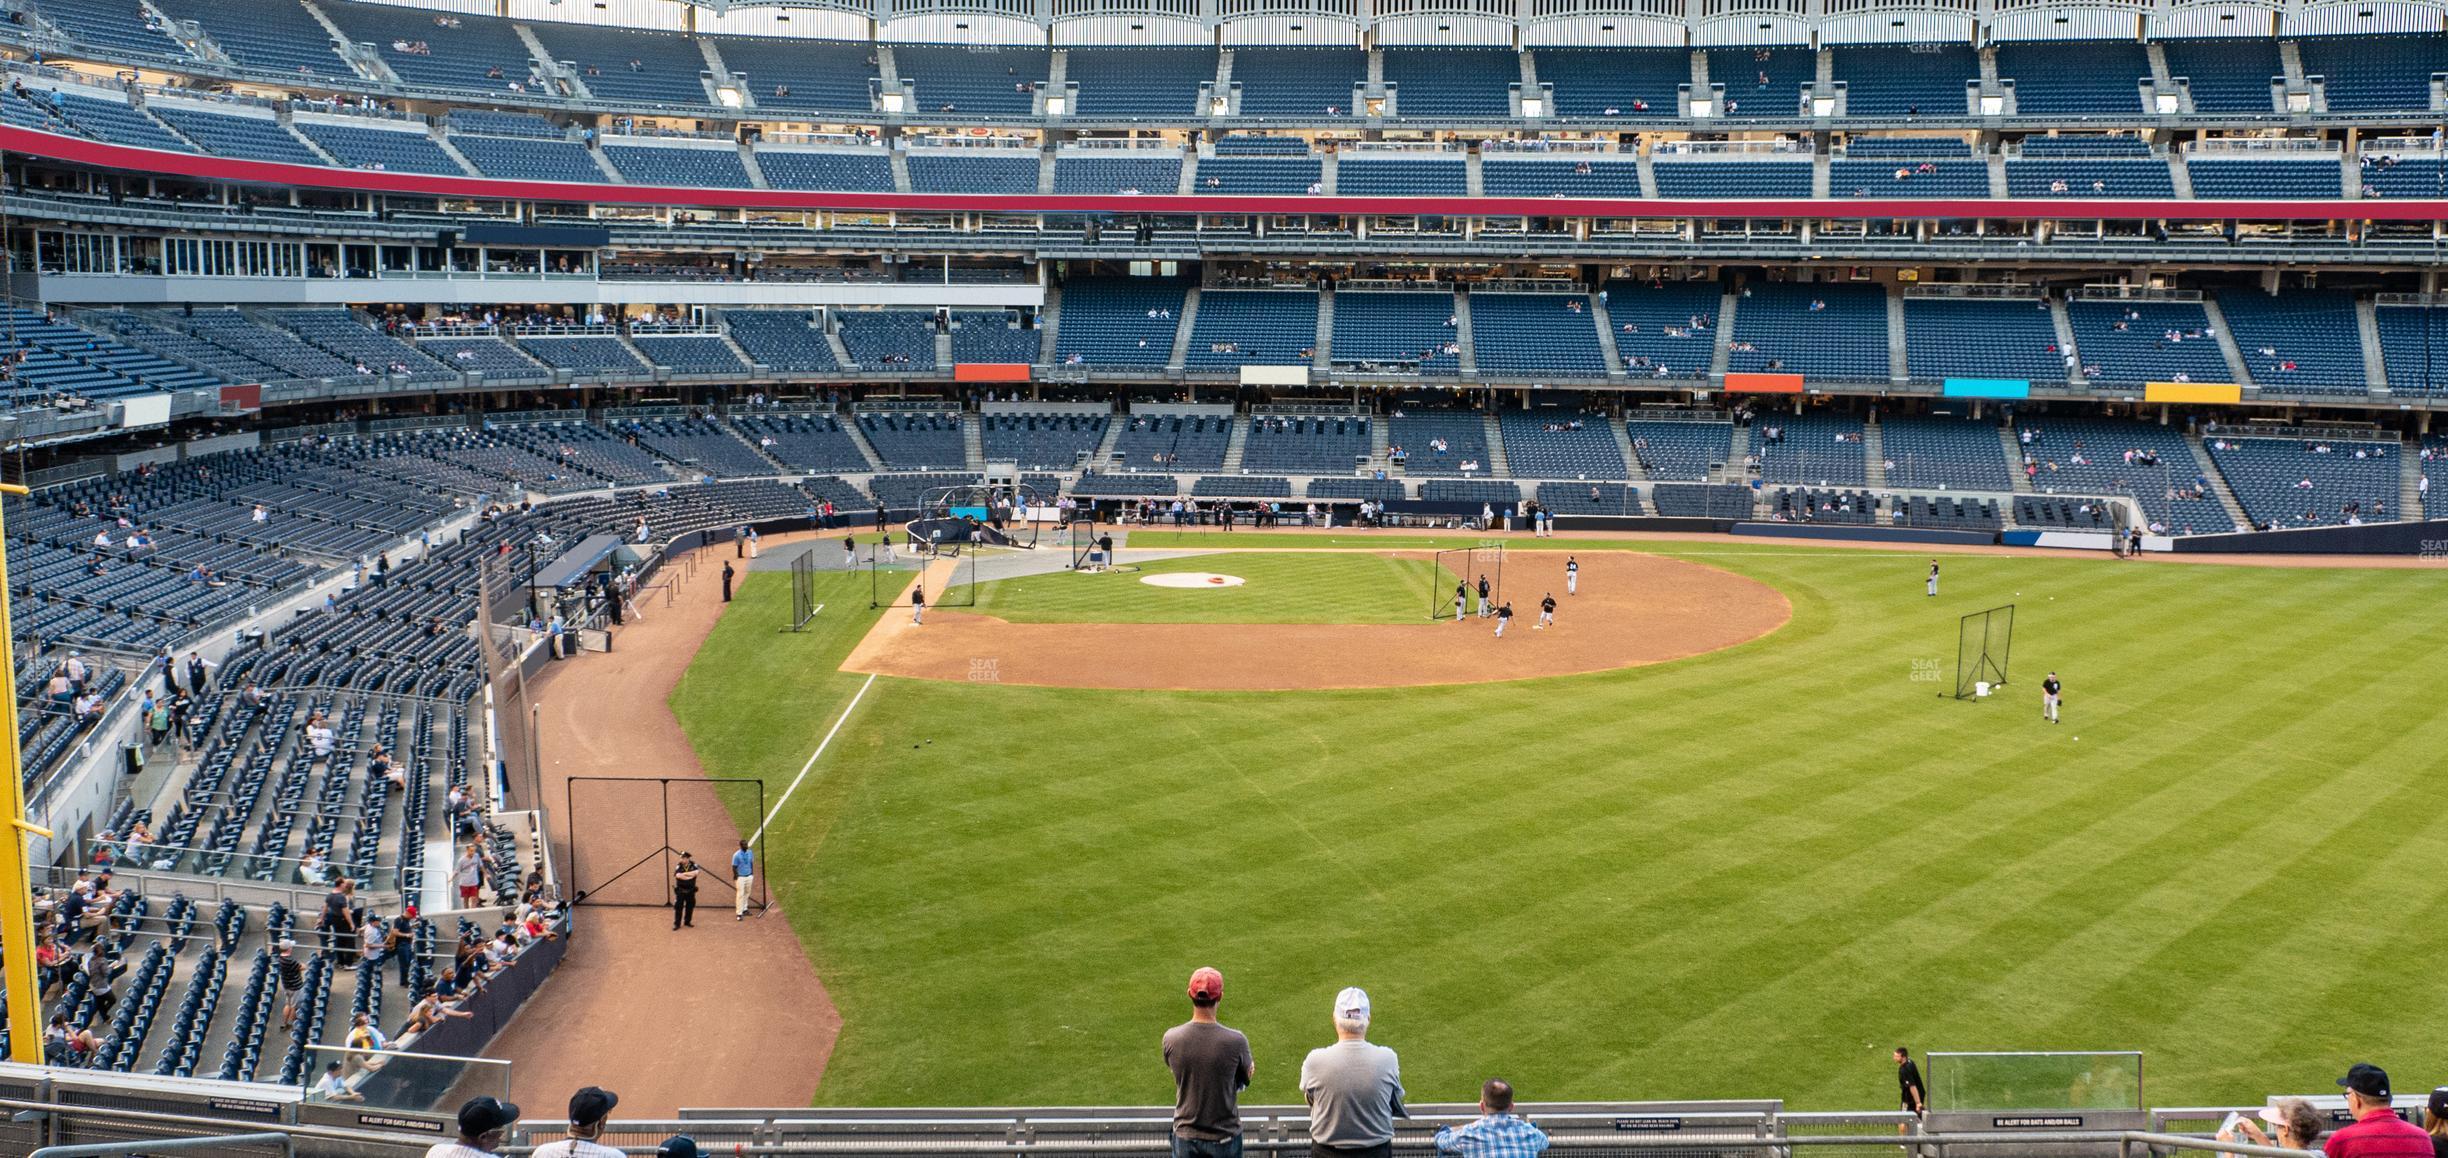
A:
<box><xmin>974</xmin><ymin>551</ymin><xmax>1437</xmax><ymax>624</ymax></box>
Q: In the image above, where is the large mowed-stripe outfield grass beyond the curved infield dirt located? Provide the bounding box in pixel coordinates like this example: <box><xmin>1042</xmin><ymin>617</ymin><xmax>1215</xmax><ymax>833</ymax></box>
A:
<box><xmin>673</xmin><ymin>548</ymin><xmax>2448</xmax><ymax>1109</ymax></box>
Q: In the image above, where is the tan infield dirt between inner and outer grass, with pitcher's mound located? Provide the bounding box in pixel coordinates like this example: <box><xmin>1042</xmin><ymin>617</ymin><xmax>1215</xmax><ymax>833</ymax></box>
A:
<box><xmin>842</xmin><ymin>551</ymin><xmax>1794</xmax><ymax>690</ymax></box>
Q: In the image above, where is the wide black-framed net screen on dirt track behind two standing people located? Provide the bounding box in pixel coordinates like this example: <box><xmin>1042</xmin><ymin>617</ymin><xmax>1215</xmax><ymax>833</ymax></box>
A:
<box><xmin>561</xmin><ymin>776</ymin><xmax>771</xmax><ymax>913</ymax></box>
